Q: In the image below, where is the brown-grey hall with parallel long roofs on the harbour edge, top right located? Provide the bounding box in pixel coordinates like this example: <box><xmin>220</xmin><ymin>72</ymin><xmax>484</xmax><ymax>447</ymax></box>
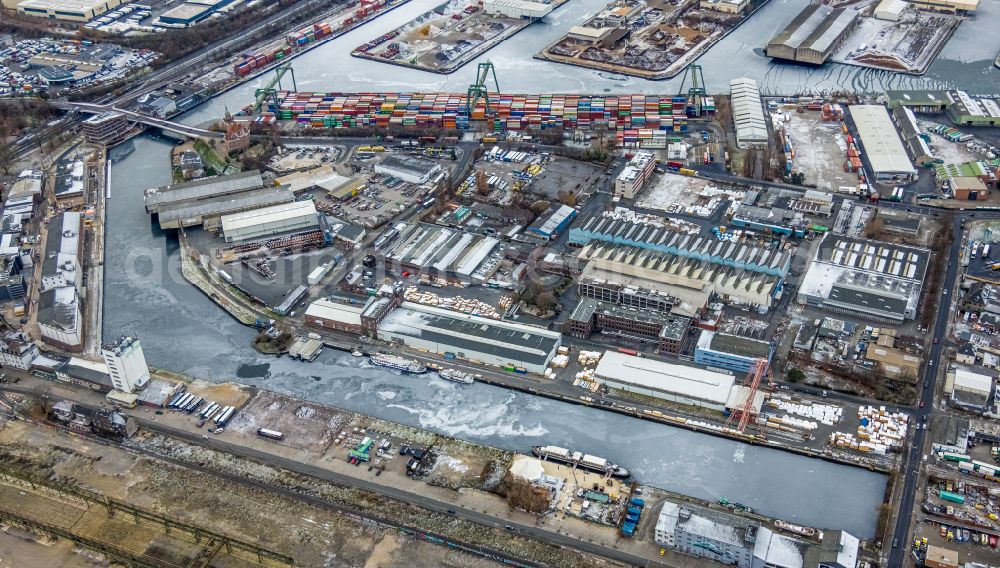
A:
<box><xmin>767</xmin><ymin>4</ymin><xmax>858</xmax><ymax>65</ymax></box>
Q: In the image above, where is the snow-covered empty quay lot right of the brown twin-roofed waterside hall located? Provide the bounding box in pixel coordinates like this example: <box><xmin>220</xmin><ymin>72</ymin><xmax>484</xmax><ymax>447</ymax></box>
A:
<box><xmin>830</xmin><ymin>9</ymin><xmax>962</xmax><ymax>75</ymax></box>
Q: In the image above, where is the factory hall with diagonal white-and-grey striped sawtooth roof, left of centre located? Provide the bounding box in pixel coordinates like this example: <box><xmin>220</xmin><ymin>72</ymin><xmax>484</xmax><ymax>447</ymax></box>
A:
<box><xmin>376</xmin><ymin>223</ymin><xmax>500</xmax><ymax>282</ymax></box>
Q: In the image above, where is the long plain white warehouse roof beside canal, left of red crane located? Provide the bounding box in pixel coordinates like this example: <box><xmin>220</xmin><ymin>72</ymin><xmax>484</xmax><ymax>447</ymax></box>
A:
<box><xmin>594</xmin><ymin>351</ymin><xmax>736</xmax><ymax>405</ymax></box>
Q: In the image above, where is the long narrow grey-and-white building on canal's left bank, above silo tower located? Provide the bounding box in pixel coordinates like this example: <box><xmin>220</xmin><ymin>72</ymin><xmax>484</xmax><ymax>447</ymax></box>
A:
<box><xmin>38</xmin><ymin>211</ymin><xmax>83</xmax><ymax>352</ymax></box>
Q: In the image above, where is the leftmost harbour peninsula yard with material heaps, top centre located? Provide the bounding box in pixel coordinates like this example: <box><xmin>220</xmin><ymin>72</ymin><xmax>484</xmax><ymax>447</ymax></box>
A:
<box><xmin>353</xmin><ymin>0</ymin><xmax>567</xmax><ymax>74</ymax></box>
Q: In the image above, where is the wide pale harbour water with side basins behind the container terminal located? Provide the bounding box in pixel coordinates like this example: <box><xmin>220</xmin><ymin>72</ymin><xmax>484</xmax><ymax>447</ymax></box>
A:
<box><xmin>183</xmin><ymin>0</ymin><xmax>1000</xmax><ymax>130</ymax></box>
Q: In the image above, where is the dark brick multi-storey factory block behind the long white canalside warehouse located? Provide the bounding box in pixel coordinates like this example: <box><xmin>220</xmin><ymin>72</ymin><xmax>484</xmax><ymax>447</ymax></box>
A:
<box><xmin>569</xmin><ymin>298</ymin><xmax>691</xmax><ymax>355</ymax></box>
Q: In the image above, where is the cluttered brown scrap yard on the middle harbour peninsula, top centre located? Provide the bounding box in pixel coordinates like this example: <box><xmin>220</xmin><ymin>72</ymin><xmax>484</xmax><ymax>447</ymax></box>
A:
<box><xmin>535</xmin><ymin>0</ymin><xmax>766</xmax><ymax>79</ymax></box>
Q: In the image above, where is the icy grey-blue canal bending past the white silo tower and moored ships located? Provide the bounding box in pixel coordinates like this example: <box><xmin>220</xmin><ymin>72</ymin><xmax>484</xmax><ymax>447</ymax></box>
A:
<box><xmin>104</xmin><ymin>136</ymin><xmax>886</xmax><ymax>537</ymax></box>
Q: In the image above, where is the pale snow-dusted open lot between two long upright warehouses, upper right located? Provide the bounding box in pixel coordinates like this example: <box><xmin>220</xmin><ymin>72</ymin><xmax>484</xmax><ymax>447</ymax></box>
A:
<box><xmin>771</xmin><ymin>108</ymin><xmax>858</xmax><ymax>193</ymax></box>
